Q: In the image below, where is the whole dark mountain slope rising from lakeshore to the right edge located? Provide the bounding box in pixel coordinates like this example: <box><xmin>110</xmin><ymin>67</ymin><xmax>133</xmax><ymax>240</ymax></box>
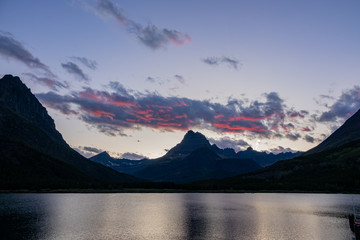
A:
<box><xmin>189</xmin><ymin>109</ymin><xmax>360</xmax><ymax>193</ymax></box>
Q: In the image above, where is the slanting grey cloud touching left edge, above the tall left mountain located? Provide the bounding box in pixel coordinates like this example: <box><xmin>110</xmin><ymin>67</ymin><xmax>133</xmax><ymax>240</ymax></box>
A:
<box><xmin>0</xmin><ymin>31</ymin><xmax>54</xmax><ymax>76</ymax></box>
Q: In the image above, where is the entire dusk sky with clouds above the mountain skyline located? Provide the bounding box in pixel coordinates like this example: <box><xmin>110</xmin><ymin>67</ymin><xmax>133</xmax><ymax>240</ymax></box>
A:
<box><xmin>0</xmin><ymin>0</ymin><xmax>360</xmax><ymax>159</ymax></box>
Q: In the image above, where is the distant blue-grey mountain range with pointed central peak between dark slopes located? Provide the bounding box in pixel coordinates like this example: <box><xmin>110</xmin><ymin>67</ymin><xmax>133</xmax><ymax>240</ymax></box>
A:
<box><xmin>90</xmin><ymin>130</ymin><xmax>301</xmax><ymax>183</ymax></box>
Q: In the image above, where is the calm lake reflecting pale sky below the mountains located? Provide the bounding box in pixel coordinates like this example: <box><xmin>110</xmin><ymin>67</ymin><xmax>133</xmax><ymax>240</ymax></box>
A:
<box><xmin>0</xmin><ymin>193</ymin><xmax>360</xmax><ymax>240</ymax></box>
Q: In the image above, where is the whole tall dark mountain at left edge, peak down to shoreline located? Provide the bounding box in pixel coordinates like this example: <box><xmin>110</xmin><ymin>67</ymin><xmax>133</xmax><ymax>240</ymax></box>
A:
<box><xmin>0</xmin><ymin>75</ymin><xmax>138</xmax><ymax>188</ymax></box>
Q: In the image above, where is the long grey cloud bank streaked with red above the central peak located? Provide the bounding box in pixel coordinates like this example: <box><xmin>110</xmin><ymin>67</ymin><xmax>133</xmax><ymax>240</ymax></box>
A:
<box><xmin>36</xmin><ymin>82</ymin><xmax>310</xmax><ymax>140</ymax></box>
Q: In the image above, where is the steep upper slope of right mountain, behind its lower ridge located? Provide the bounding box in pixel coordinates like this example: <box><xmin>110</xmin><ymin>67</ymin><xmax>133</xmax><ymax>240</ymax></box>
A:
<box><xmin>305</xmin><ymin>110</ymin><xmax>360</xmax><ymax>155</ymax></box>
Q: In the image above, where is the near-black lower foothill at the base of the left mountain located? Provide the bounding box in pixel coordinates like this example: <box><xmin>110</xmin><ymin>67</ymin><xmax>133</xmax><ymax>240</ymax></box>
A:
<box><xmin>0</xmin><ymin>140</ymin><xmax>97</xmax><ymax>190</ymax></box>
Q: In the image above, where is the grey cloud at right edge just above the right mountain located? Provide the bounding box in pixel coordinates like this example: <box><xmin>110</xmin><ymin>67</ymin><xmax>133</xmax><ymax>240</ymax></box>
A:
<box><xmin>318</xmin><ymin>86</ymin><xmax>360</xmax><ymax>122</ymax></box>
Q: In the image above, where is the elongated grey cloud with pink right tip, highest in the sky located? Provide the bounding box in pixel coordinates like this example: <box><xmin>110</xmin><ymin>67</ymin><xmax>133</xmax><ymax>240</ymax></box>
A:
<box><xmin>95</xmin><ymin>0</ymin><xmax>191</xmax><ymax>49</ymax></box>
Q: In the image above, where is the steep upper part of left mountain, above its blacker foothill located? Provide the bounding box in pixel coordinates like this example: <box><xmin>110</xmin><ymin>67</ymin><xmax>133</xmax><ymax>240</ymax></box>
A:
<box><xmin>0</xmin><ymin>75</ymin><xmax>137</xmax><ymax>188</ymax></box>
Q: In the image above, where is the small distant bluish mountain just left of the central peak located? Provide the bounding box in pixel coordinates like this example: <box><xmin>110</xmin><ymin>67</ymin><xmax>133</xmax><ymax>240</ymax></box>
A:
<box><xmin>89</xmin><ymin>152</ymin><xmax>152</xmax><ymax>175</ymax></box>
